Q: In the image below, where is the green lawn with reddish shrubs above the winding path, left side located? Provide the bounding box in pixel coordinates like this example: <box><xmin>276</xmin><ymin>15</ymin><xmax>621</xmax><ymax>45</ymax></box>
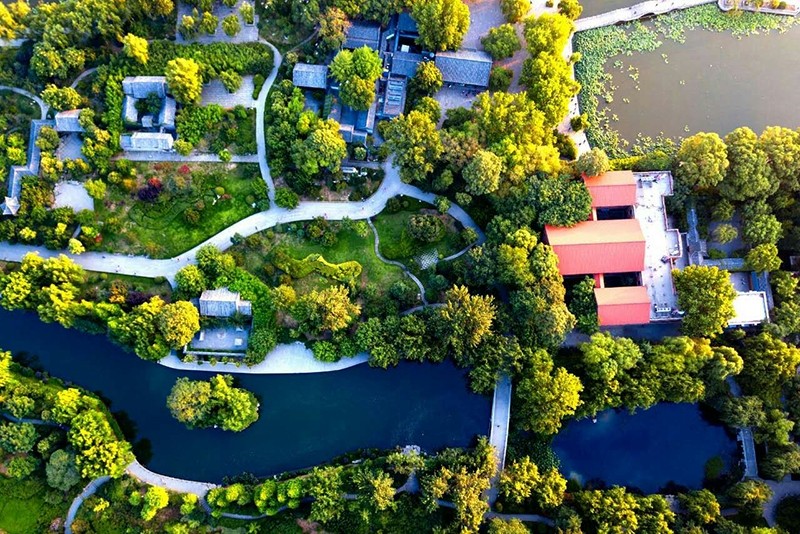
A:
<box><xmin>95</xmin><ymin>162</ymin><xmax>266</xmax><ymax>258</ymax></box>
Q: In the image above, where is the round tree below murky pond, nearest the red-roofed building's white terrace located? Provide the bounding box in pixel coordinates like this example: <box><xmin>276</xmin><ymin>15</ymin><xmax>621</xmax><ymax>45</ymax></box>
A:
<box><xmin>675</xmin><ymin>132</ymin><xmax>730</xmax><ymax>192</ymax></box>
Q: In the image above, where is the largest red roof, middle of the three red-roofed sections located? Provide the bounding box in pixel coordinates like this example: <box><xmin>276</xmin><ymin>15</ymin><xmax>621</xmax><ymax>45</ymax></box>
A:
<box><xmin>545</xmin><ymin>219</ymin><xmax>645</xmax><ymax>276</ymax></box>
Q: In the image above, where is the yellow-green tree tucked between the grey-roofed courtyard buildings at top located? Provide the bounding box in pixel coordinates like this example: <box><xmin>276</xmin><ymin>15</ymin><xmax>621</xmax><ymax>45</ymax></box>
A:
<box><xmin>328</xmin><ymin>46</ymin><xmax>383</xmax><ymax>110</ymax></box>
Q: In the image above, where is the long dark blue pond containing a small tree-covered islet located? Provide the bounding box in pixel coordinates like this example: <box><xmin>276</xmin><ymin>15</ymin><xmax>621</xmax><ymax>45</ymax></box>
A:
<box><xmin>0</xmin><ymin>311</ymin><xmax>491</xmax><ymax>482</ymax></box>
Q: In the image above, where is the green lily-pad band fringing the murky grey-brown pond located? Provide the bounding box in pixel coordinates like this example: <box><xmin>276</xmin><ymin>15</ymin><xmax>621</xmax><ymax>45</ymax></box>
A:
<box><xmin>573</xmin><ymin>4</ymin><xmax>797</xmax><ymax>158</ymax></box>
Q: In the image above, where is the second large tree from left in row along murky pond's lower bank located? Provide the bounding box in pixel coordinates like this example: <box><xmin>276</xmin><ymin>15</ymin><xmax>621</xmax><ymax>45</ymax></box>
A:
<box><xmin>719</xmin><ymin>126</ymin><xmax>778</xmax><ymax>202</ymax></box>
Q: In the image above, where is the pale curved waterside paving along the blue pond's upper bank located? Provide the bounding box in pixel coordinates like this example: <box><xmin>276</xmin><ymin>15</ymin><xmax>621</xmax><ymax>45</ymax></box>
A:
<box><xmin>158</xmin><ymin>341</ymin><xmax>369</xmax><ymax>375</ymax></box>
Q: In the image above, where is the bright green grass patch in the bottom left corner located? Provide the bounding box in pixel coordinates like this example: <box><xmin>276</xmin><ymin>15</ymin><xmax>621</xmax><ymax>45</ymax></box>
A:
<box><xmin>0</xmin><ymin>478</ymin><xmax>72</xmax><ymax>534</ymax></box>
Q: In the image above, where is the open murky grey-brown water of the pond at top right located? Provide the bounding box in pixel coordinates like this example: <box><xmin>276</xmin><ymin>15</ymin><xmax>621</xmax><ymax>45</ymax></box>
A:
<box><xmin>601</xmin><ymin>25</ymin><xmax>800</xmax><ymax>143</ymax></box>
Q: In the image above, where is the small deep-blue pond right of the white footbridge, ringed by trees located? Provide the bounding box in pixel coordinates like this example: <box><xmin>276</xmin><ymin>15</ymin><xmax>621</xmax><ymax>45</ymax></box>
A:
<box><xmin>553</xmin><ymin>403</ymin><xmax>739</xmax><ymax>493</ymax></box>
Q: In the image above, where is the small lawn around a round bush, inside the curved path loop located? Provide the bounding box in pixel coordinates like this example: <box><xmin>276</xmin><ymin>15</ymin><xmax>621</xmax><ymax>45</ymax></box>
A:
<box><xmin>374</xmin><ymin>198</ymin><xmax>464</xmax><ymax>270</ymax></box>
